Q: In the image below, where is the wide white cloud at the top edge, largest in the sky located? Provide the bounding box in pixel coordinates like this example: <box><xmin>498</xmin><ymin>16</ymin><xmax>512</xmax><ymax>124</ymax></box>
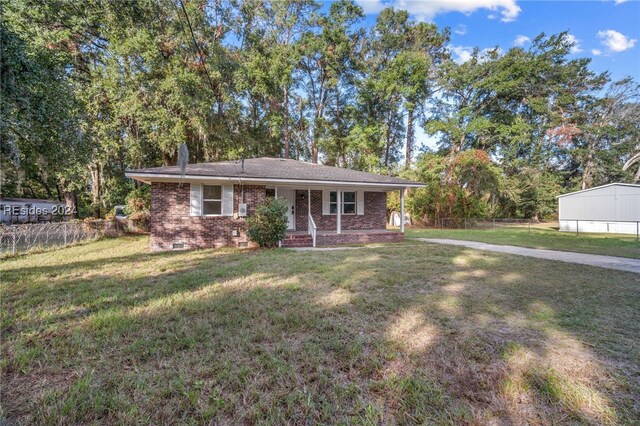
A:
<box><xmin>356</xmin><ymin>0</ymin><xmax>522</xmax><ymax>22</ymax></box>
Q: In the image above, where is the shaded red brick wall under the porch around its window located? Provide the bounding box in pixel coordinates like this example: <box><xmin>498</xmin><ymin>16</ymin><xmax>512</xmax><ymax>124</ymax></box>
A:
<box><xmin>296</xmin><ymin>190</ymin><xmax>387</xmax><ymax>231</ymax></box>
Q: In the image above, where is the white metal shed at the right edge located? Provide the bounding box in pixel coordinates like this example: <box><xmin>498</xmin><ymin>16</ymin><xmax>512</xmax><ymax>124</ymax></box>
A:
<box><xmin>558</xmin><ymin>183</ymin><xmax>640</xmax><ymax>234</ymax></box>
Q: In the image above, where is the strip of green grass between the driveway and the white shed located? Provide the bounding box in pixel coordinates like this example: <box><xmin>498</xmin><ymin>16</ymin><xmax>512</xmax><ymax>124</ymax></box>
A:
<box><xmin>406</xmin><ymin>225</ymin><xmax>640</xmax><ymax>259</ymax></box>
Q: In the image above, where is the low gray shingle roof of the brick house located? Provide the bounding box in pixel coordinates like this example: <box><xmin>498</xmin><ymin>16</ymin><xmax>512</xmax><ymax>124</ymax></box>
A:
<box><xmin>127</xmin><ymin>157</ymin><xmax>420</xmax><ymax>186</ymax></box>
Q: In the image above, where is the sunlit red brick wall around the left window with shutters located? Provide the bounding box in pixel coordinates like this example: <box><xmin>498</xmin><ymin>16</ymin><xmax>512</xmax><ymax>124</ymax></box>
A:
<box><xmin>151</xmin><ymin>182</ymin><xmax>266</xmax><ymax>250</ymax></box>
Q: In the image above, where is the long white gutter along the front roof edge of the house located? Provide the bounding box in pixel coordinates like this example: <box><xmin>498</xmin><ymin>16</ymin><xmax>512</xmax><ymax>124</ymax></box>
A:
<box><xmin>125</xmin><ymin>172</ymin><xmax>426</xmax><ymax>189</ymax></box>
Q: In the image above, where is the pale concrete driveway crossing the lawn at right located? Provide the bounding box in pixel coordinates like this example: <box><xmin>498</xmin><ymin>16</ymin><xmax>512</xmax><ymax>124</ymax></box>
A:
<box><xmin>414</xmin><ymin>238</ymin><xmax>640</xmax><ymax>274</ymax></box>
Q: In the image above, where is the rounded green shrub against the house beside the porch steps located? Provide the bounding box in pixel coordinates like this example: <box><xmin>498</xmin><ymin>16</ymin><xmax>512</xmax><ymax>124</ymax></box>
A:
<box><xmin>247</xmin><ymin>198</ymin><xmax>287</xmax><ymax>247</ymax></box>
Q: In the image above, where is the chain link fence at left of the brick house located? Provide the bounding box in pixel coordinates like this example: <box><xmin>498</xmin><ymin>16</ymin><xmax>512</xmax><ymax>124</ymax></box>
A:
<box><xmin>0</xmin><ymin>220</ymin><xmax>126</xmax><ymax>257</ymax></box>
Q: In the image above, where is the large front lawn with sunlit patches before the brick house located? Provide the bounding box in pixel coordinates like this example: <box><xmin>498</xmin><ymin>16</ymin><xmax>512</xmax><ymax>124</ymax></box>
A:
<box><xmin>0</xmin><ymin>237</ymin><xmax>640</xmax><ymax>424</ymax></box>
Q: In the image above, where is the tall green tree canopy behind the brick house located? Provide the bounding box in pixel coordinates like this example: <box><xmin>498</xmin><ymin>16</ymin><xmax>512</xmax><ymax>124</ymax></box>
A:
<box><xmin>0</xmin><ymin>0</ymin><xmax>640</xmax><ymax>221</ymax></box>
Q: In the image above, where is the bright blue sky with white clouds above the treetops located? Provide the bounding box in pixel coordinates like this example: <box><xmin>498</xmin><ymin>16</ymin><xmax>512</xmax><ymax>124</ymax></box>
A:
<box><xmin>336</xmin><ymin>0</ymin><xmax>640</xmax><ymax>153</ymax></box>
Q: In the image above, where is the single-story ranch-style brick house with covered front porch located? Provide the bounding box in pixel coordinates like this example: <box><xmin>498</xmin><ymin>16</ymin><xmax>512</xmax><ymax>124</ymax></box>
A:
<box><xmin>126</xmin><ymin>158</ymin><xmax>423</xmax><ymax>250</ymax></box>
